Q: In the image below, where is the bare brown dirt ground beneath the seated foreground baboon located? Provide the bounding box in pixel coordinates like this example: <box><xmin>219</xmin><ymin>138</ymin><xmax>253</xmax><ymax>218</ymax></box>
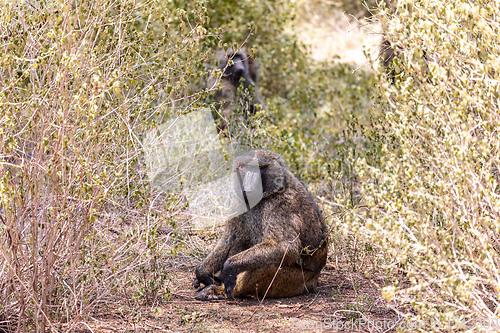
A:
<box><xmin>73</xmin><ymin>263</ymin><xmax>401</xmax><ymax>333</ymax></box>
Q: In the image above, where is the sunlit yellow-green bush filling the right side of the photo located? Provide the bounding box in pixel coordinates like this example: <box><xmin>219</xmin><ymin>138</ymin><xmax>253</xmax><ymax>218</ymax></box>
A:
<box><xmin>358</xmin><ymin>0</ymin><xmax>500</xmax><ymax>331</ymax></box>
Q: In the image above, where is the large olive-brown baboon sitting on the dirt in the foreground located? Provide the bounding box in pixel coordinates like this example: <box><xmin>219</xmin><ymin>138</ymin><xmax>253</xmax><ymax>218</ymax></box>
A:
<box><xmin>193</xmin><ymin>149</ymin><xmax>328</xmax><ymax>301</ymax></box>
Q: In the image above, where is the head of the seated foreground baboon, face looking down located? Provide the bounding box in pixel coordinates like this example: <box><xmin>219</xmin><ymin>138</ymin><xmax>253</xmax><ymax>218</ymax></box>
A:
<box><xmin>233</xmin><ymin>150</ymin><xmax>286</xmax><ymax>208</ymax></box>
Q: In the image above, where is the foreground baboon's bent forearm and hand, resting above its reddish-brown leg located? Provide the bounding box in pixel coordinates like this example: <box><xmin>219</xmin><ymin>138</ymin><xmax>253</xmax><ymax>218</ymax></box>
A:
<box><xmin>222</xmin><ymin>237</ymin><xmax>300</xmax><ymax>299</ymax></box>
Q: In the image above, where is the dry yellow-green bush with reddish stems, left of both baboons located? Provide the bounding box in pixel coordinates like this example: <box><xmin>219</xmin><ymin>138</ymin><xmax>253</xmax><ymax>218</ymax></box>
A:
<box><xmin>0</xmin><ymin>0</ymin><xmax>213</xmax><ymax>332</ymax></box>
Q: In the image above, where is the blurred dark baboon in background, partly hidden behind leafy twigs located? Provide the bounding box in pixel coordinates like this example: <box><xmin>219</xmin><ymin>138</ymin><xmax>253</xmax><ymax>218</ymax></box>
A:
<box><xmin>209</xmin><ymin>48</ymin><xmax>265</xmax><ymax>129</ymax></box>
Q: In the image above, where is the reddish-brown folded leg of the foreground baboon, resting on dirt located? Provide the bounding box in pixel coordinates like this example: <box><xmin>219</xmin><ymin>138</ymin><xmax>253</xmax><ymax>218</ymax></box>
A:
<box><xmin>234</xmin><ymin>266</ymin><xmax>319</xmax><ymax>298</ymax></box>
